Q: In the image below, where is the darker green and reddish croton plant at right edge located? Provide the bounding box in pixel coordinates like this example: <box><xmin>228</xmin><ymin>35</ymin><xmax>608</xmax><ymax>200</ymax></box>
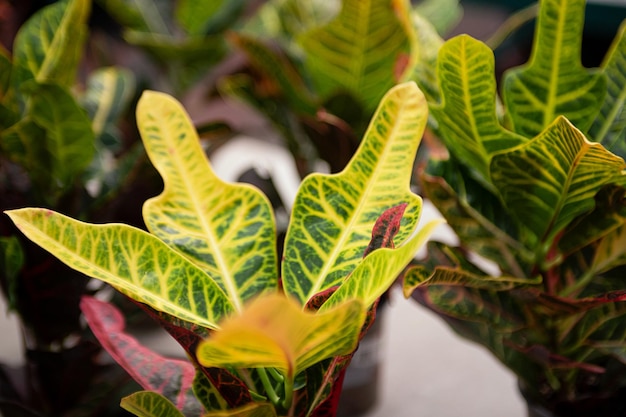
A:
<box><xmin>404</xmin><ymin>0</ymin><xmax>626</xmax><ymax>416</ymax></box>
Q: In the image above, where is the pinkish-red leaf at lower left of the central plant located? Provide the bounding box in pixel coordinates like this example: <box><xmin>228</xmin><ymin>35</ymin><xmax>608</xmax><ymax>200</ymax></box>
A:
<box><xmin>80</xmin><ymin>297</ymin><xmax>203</xmax><ymax>416</ymax></box>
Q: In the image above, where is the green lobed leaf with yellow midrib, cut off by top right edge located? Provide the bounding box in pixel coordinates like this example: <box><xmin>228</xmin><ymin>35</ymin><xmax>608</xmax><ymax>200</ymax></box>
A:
<box><xmin>503</xmin><ymin>0</ymin><xmax>607</xmax><ymax>137</ymax></box>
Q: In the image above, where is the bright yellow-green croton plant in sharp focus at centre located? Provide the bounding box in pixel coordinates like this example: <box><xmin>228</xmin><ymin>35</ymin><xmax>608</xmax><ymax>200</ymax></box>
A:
<box><xmin>8</xmin><ymin>83</ymin><xmax>435</xmax><ymax>417</ymax></box>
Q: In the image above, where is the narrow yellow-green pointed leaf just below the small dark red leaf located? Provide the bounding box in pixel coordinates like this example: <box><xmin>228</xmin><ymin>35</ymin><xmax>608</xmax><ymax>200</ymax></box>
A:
<box><xmin>320</xmin><ymin>221</ymin><xmax>441</xmax><ymax>311</ymax></box>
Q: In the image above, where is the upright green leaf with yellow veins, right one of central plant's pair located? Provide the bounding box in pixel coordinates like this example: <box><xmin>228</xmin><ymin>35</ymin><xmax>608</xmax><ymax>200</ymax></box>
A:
<box><xmin>282</xmin><ymin>83</ymin><xmax>427</xmax><ymax>305</ymax></box>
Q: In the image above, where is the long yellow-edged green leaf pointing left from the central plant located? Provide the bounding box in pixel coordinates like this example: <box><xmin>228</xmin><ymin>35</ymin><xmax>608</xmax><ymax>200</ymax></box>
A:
<box><xmin>6</xmin><ymin>208</ymin><xmax>233</xmax><ymax>329</ymax></box>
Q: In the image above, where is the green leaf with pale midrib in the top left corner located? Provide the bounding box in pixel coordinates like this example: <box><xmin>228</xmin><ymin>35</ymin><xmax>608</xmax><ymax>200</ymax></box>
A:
<box><xmin>13</xmin><ymin>0</ymin><xmax>91</xmax><ymax>88</ymax></box>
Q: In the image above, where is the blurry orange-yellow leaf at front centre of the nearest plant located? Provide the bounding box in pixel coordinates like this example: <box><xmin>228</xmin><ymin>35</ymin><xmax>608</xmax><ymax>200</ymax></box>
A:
<box><xmin>197</xmin><ymin>293</ymin><xmax>365</xmax><ymax>379</ymax></box>
